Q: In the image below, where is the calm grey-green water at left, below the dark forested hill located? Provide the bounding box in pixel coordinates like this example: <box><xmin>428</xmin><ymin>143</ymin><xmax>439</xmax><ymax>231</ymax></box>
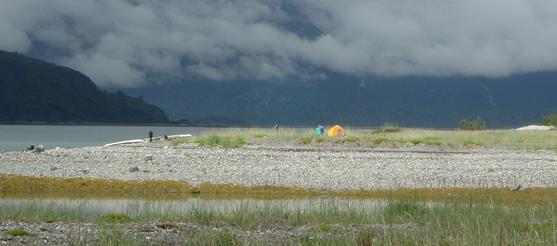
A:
<box><xmin>0</xmin><ymin>125</ymin><xmax>211</xmax><ymax>151</ymax></box>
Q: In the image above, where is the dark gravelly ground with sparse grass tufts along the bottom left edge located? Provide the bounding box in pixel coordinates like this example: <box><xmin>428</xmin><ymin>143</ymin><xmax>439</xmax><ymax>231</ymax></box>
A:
<box><xmin>0</xmin><ymin>221</ymin><xmax>418</xmax><ymax>245</ymax></box>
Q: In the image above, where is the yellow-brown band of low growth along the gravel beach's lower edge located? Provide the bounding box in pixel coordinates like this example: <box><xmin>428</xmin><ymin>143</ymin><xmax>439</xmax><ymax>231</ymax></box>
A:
<box><xmin>5</xmin><ymin>175</ymin><xmax>557</xmax><ymax>205</ymax></box>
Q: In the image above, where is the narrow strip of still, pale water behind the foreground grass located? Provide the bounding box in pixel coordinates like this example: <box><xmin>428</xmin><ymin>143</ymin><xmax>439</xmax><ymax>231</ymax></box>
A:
<box><xmin>0</xmin><ymin>197</ymin><xmax>386</xmax><ymax>216</ymax></box>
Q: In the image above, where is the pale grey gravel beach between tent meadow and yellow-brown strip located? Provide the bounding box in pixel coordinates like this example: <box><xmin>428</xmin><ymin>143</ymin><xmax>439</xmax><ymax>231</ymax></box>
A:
<box><xmin>0</xmin><ymin>144</ymin><xmax>557</xmax><ymax>191</ymax></box>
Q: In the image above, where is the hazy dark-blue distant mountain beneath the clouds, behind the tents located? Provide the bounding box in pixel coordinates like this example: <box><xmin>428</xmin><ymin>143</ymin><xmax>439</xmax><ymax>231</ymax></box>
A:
<box><xmin>126</xmin><ymin>72</ymin><xmax>557</xmax><ymax>128</ymax></box>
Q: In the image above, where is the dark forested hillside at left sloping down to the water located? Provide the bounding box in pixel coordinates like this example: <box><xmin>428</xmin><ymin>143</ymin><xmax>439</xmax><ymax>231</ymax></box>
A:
<box><xmin>0</xmin><ymin>51</ymin><xmax>168</xmax><ymax>123</ymax></box>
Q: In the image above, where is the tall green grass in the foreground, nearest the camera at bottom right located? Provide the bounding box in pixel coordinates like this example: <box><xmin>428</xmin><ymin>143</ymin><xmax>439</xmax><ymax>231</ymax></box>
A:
<box><xmin>1</xmin><ymin>200</ymin><xmax>557</xmax><ymax>245</ymax></box>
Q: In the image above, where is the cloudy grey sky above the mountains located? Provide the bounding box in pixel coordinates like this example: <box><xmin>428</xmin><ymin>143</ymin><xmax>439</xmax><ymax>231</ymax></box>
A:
<box><xmin>0</xmin><ymin>0</ymin><xmax>557</xmax><ymax>87</ymax></box>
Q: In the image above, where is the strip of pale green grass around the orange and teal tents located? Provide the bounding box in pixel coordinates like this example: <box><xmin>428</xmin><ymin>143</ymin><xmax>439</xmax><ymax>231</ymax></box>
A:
<box><xmin>185</xmin><ymin>126</ymin><xmax>557</xmax><ymax>151</ymax></box>
